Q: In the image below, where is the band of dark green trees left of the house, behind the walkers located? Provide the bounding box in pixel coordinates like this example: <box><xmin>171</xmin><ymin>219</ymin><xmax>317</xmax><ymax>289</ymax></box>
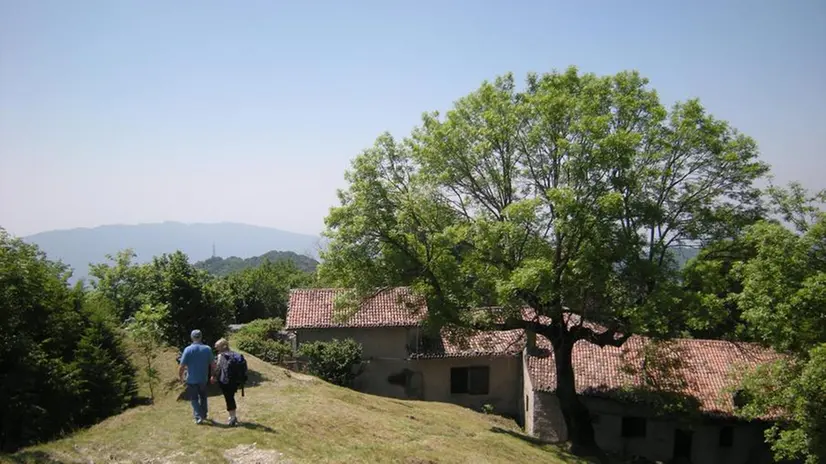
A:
<box><xmin>0</xmin><ymin>239</ymin><xmax>315</xmax><ymax>451</ymax></box>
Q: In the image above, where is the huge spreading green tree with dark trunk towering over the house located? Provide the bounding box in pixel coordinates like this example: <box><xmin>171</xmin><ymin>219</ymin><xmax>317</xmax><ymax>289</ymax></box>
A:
<box><xmin>320</xmin><ymin>68</ymin><xmax>767</xmax><ymax>446</ymax></box>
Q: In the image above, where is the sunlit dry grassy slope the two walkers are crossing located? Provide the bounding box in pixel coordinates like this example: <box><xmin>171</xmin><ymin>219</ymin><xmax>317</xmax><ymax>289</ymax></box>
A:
<box><xmin>0</xmin><ymin>346</ymin><xmax>583</xmax><ymax>464</ymax></box>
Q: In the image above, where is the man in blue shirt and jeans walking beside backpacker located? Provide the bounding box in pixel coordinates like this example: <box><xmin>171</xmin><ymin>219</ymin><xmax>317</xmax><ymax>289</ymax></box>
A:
<box><xmin>178</xmin><ymin>329</ymin><xmax>215</xmax><ymax>424</ymax></box>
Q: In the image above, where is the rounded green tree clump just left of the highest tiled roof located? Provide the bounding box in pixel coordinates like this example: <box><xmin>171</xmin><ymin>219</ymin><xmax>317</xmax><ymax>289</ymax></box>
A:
<box><xmin>220</xmin><ymin>261</ymin><xmax>312</xmax><ymax>324</ymax></box>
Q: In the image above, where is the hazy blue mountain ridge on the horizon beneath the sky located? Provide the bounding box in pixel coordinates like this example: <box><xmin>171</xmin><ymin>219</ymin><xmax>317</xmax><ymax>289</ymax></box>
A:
<box><xmin>23</xmin><ymin>222</ymin><xmax>321</xmax><ymax>281</ymax></box>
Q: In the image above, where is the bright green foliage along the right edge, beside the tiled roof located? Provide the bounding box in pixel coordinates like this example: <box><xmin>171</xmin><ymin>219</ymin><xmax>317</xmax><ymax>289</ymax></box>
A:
<box><xmin>735</xmin><ymin>198</ymin><xmax>826</xmax><ymax>464</ymax></box>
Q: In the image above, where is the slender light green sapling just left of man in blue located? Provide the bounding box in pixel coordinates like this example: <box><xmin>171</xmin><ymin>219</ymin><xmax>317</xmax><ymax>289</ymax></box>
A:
<box><xmin>127</xmin><ymin>305</ymin><xmax>170</xmax><ymax>402</ymax></box>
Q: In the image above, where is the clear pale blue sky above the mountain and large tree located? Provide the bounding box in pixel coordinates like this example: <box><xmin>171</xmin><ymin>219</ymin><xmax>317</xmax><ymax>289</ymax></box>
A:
<box><xmin>0</xmin><ymin>0</ymin><xmax>826</xmax><ymax>235</ymax></box>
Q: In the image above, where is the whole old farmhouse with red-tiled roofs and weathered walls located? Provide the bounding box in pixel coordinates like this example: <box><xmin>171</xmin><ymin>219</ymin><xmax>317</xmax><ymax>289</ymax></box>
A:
<box><xmin>286</xmin><ymin>288</ymin><xmax>774</xmax><ymax>464</ymax></box>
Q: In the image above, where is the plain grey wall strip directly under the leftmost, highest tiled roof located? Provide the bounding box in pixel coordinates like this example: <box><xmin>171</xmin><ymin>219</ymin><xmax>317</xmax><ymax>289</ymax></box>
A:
<box><xmin>295</xmin><ymin>327</ymin><xmax>419</xmax><ymax>359</ymax></box>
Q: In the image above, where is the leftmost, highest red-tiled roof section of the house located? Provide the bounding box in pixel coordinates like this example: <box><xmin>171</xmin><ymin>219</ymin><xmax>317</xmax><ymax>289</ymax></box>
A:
<box><xmin>286</xmin><ymin>287</ymin><xmax>427</xmax><ymax>330</ymax></box>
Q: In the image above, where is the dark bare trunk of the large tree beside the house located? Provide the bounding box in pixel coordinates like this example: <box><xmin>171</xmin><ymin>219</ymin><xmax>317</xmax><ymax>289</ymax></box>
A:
<box><xmin>554</xmin><ymin>334</ymin><xmax>598</xmax><ymax>452</ymax></box>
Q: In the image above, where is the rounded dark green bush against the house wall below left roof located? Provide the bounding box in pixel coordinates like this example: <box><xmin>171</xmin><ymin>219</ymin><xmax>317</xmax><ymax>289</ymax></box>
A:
<box><xmin>298</xmin><ymin>338</ymin><xmax>362</xmax><ymax>387</ymax></box>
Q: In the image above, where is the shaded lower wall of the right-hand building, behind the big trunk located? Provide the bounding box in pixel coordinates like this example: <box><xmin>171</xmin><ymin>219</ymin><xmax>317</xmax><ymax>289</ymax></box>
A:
<box><xmin>528</xmin><ymin>392</ymin><xmax>772</xmax><ymax>464</ymax></box>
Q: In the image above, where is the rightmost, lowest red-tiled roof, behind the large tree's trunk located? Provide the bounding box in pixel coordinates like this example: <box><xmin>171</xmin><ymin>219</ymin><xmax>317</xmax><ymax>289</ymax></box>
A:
<box><xmin>527</xmin><ymin>336</ymin><xmax>778</xmax><ymax>416</ymax></box>
